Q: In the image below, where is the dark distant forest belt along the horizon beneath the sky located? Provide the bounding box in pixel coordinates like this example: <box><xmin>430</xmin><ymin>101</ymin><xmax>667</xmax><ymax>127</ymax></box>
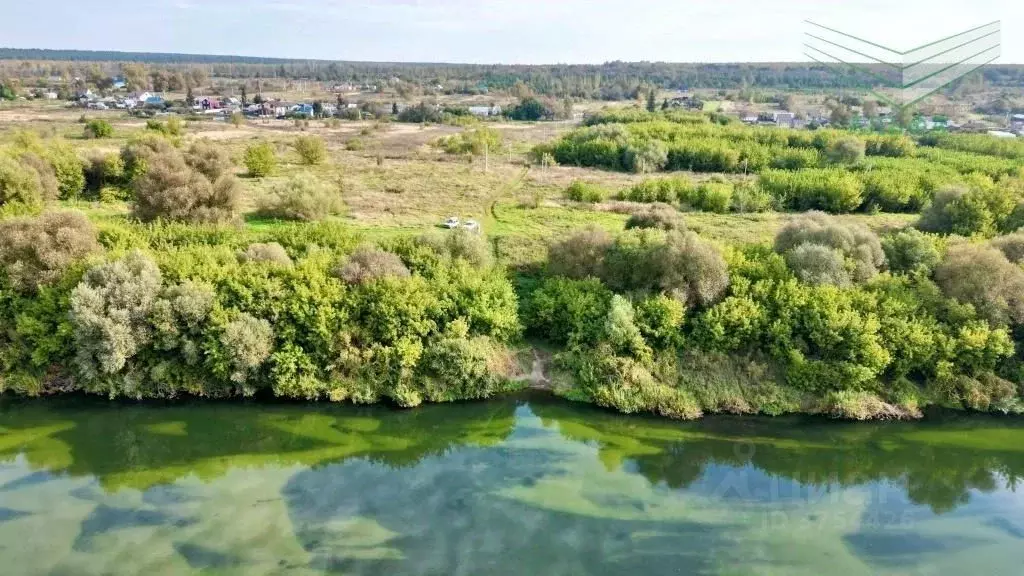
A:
<box><xmin>0</xmin><ymin>48</ymin><xmax>1024</xmax><ymax>95</ymax></box>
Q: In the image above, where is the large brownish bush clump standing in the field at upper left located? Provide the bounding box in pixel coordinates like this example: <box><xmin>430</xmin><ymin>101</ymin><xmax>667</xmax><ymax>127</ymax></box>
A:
<box><xmin>133</xmin><ymin>148</ymin><xmax>241</xmax><ymax>222</ymax></box>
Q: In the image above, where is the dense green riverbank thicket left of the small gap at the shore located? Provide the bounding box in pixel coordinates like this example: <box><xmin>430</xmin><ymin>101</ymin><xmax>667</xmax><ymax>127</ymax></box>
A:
<box><xmin>0</xmin><ymin>213</ymin><xmax>519</xmax><ymax>406</ymax></box>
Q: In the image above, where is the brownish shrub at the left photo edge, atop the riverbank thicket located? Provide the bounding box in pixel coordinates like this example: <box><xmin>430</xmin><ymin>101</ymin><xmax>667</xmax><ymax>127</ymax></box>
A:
<box><xmin>0</xmin><ymin>212</ymin><xmax>100</xmax><ymax>292</ymax></box>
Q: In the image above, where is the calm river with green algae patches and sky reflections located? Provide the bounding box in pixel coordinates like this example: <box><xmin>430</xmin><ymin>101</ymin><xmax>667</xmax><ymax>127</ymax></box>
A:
<box><xmin>0</xmin><ymin>397</ymin><xmax>1024</xmax><ymax>576</ymax></box>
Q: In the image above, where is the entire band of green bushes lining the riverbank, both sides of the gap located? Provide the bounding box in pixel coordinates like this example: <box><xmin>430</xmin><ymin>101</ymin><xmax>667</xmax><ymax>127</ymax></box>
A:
<box><xmin>0</xmin><ymin>204</ymin><xmax>1024</xmax><ymax>418</ymax></box>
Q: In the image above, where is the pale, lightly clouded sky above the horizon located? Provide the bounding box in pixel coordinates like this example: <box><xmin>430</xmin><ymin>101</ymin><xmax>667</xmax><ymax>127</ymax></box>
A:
<box><xmin>0</xmin><ymin>0</ymin><xmax>1024</xmax><ymax>64</ymax></box>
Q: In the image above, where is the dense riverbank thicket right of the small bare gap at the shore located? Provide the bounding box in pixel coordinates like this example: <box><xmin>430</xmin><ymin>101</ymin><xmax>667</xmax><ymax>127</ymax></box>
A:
<box><xmin>523</xmin><ymin>213</ymin><xmax>1024</xmax><ymax>418</ymax></box>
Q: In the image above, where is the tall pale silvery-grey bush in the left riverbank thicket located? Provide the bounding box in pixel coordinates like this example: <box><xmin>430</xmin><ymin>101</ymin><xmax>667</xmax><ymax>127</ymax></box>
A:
<box><xmin>71</xmin><ymin>251</ymin><xmax>161</xmax><ymax>383</ymax></box>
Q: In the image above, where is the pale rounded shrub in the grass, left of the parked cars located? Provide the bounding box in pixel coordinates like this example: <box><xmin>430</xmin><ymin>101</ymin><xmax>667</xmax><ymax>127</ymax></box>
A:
<box><xmin>258</xmin><ymin>173</ymin><xmax>343</xmax><ymax>221</ymax></box>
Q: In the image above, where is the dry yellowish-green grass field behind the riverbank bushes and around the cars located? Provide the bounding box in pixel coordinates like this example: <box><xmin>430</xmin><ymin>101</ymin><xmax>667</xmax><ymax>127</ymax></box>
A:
<box><xmin>0</xmin><ymin>100</ymin><xmax>913</xmax><ymax>262</ymax></box>
